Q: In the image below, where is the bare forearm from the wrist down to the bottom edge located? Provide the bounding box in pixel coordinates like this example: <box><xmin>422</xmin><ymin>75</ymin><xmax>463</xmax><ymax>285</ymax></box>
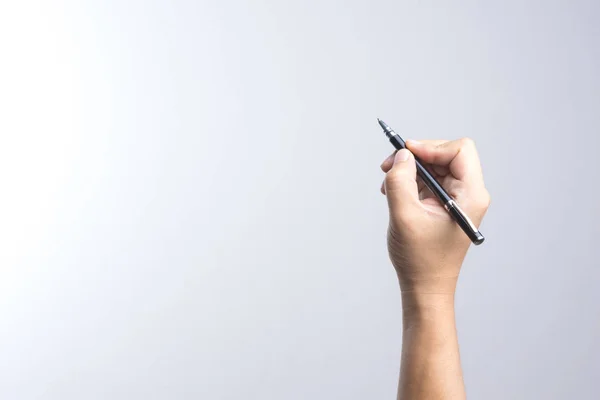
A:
<box><xmin>398</xmin><ymin>293</ymin><xmax>465</xmax><ymax>400</ymax></box>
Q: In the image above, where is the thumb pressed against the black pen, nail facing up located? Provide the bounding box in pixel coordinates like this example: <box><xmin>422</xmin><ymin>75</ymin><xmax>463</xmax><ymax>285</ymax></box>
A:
<box><xmin>385</xmin><ymin>149</ymin><xmax>419</xmax><ymax>218</ymax></box>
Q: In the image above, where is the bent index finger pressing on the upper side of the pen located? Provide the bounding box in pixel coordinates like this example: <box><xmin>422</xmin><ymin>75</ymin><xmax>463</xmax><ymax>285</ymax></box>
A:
<box><xmin>406</xmin><ymin>138</ymin><xmax>483</xmax><ymax>185</ymax></box>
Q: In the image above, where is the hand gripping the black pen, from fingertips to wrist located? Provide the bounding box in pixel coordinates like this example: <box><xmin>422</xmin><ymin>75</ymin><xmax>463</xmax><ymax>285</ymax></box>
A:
<box><xmin>381</xmin><ymin>139</ymin><xmax>490</xmax><ymax>294</ymax></box>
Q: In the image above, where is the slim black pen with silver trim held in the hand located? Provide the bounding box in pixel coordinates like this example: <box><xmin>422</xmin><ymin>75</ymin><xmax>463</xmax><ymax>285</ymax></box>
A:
<box><xmin>377</xmin><ymin>118</ymin><xmax>485</xmax><ymax>245</ymax></box>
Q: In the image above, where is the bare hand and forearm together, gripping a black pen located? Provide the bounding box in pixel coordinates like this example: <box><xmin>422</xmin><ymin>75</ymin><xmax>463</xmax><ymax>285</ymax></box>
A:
<box><xmin>381</xmin><ymin>139</ymin><xmax>490</xmax><ymax>400</ymax></box>
